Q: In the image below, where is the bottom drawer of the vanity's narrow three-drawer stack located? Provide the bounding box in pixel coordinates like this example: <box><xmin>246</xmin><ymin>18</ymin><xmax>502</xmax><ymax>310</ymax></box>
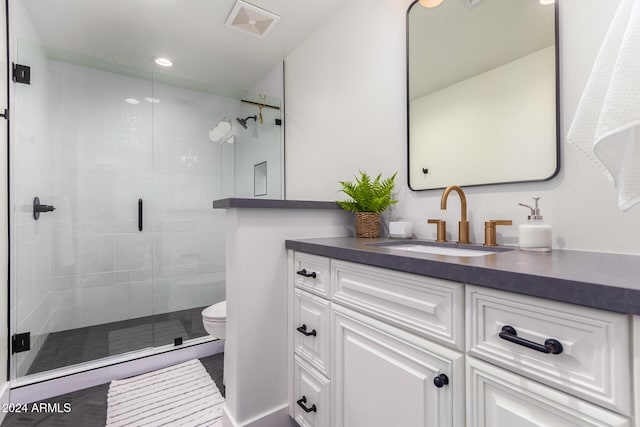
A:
<box><xmin>291</xmin><ymin>356</ymin><xmax>331</xmax><ymax>427</ymax></box>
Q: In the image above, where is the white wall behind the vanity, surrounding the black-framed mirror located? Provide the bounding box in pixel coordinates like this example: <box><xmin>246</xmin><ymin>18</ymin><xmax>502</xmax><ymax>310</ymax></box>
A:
<box><xmin>285</xmin><ymin>0</ymin><xmax>640</xmax><ymax>254</ymax></box>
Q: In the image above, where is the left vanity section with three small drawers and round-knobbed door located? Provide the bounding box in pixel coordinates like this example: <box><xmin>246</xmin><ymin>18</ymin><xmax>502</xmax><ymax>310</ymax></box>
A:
<box><xmin>289</xmin><ymin>251</ymin><xmax>465</xmax><ymax>427</ymax></box>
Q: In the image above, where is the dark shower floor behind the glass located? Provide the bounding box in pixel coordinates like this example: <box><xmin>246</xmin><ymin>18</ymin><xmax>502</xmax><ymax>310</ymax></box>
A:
<box><xmin>27</xmin><ymin>307</ymin><xmax>207</xmax><ymax>375</ymax></box>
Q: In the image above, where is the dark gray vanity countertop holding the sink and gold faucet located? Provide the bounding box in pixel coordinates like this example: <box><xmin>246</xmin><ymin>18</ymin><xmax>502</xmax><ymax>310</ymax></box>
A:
<box><xmin>286</xmin><ymin>237</ymin><xmax>640</xmax><ymax>315</ymax></box>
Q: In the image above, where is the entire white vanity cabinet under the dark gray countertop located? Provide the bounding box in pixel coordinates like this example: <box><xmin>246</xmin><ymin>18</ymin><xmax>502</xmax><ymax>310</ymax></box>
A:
<box><xmin>289</xmin><ymin>251</ymin><xmax>640</xmax><ymax>427</ymax></box>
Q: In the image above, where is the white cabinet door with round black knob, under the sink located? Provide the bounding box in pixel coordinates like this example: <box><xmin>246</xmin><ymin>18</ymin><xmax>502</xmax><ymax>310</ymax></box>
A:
<box><xmin>331</xmin><ymin>304</ymin><xmax>464</xmax><ymax>427</ymax></box>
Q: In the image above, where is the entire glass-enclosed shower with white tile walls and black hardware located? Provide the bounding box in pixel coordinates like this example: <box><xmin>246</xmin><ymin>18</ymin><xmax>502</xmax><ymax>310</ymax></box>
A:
<box><xmin>10</xmin><ymin>39</ymin><xmax>282</xmax><ymax>379</ymax></box>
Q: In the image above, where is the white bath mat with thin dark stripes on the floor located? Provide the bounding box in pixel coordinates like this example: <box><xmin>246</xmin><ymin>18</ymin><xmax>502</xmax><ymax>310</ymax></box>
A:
<box><xmin>107</xmin><ymin>360</ymin><xmax>224</xmax><ymax>427</ymax></box>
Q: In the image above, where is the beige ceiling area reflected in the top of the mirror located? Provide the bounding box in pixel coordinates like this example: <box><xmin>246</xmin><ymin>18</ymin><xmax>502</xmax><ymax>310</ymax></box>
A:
<box><xmin>409</xmin><ymin>0</ymin><xmax>555</xmax><ymax>99</ymax></box>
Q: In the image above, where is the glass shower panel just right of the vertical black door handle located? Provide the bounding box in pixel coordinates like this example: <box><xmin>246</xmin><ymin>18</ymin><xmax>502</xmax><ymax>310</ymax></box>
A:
<box><xmin>150</xmin><ymin>73</ymin><xmax>229</xmax><ymax>347</ymax></box>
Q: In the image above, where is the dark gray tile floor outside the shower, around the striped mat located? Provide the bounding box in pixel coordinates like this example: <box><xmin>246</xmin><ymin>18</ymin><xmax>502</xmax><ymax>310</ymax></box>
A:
<box><xmin>2</xmin><ymin>353</ymin><xmax>225</xmax><ymax>427</ymax></box>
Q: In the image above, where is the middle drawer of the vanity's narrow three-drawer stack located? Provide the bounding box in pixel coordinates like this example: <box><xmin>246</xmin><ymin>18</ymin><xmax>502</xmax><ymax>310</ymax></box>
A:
<box><xmin>293</xmin><ymin>289</ymin><xmax>331</xmax><ymax>376</ymax></box>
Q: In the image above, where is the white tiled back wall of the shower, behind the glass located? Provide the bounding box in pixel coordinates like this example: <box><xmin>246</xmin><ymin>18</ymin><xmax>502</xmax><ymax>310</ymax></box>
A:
<box><xmin>14</xmin><ymin>60</ymin><xmax>239</xmax><ymax>334</ymax></box>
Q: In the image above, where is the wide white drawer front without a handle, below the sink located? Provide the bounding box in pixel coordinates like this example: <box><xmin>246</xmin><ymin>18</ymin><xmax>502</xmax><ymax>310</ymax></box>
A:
<box><xmin>331</xmin><ymin>260</ymin><xmax>464</xmax><ymax>350</ymax></box>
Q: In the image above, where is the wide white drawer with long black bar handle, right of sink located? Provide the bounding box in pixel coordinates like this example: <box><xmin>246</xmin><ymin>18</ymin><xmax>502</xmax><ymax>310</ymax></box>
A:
<box><xmin>466</xmin><ymin>285</ymin><xmax>632</xmax><ymax>415</ymax></box>
